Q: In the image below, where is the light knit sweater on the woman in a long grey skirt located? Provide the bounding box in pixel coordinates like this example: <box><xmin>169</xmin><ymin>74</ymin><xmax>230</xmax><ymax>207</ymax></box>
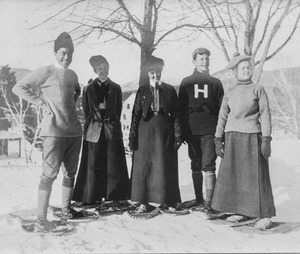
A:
<box><xmin>215</xmin><ymin>83</ymin><xmax>271</xmax><ymax>137</ymax></box>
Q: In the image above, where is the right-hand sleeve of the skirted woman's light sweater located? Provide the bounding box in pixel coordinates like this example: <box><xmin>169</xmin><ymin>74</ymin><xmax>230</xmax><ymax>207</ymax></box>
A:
<box><xmin>258</xmin><ymin>86</ymin><xmax>272</xmax><ymax>136</ymax></box>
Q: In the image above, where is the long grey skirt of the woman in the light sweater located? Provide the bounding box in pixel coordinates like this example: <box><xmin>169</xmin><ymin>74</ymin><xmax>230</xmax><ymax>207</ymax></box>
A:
<box><xmin>212</xmin><ymin>132</ymin><xmax>275</xmax><ymax>218</ymax></box>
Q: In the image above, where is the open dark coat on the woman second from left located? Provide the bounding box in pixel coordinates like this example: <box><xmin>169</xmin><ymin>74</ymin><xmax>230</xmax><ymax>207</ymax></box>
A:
<box><xmin>82</xmin><ymin>78</ymin><xmax>123</xmax><ymax>140</ymax></box>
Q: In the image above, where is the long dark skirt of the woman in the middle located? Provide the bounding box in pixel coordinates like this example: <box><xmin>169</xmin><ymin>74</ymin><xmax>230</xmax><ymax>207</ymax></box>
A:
<box><xmin>131</xmin><ymin>115</ymin><xmax>181</xmax><ymax>204</ymax></box>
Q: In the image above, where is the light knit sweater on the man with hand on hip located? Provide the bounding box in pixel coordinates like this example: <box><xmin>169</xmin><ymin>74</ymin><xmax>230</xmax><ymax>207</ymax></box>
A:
<box><xmin>13</xmin><ymin>65</ymin><xmax>82</xmax><ymax>137</ymax></box>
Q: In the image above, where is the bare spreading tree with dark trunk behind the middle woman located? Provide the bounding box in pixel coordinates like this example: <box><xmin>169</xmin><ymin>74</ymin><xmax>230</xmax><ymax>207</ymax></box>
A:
<box><xmin>33</xmin><ymin>0</ymin><xmax>222</xmax><ymax>84</ymax></box>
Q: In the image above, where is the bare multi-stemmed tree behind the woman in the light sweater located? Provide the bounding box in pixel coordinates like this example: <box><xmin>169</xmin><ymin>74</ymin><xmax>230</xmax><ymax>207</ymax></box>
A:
<box><xmin>194</xmin><ymin>0</ymin><xmax>300</xmax><ymax>82</ymax></box>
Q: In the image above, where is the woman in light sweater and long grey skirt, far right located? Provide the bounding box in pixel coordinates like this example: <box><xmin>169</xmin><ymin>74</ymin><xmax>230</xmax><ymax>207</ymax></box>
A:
<box><xmin>212</xmin><ymin>54</ymin><xmax>275</xmax><ymax>229</ymax></box>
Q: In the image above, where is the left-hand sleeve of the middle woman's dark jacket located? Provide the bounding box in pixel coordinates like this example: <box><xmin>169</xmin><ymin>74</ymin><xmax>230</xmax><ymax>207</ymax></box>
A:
<box><xmin>129</xmin><ymin>88</ymin><xmax>142</xmax><ymax>139</ymax></box>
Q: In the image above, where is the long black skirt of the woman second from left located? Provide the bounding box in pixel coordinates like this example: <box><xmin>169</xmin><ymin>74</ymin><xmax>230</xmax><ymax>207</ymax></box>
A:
<box><xmin>72</xmin><ymin>129</ymin><xmax>130</xmax><ymax>203</ymax></box>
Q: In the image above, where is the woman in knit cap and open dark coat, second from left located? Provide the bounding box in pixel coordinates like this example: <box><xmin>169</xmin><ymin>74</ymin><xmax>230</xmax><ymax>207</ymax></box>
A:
<box><xmin>72</xmin><ymin>55</ymin><xmax>130</xmax><ymax>206</ymax></box>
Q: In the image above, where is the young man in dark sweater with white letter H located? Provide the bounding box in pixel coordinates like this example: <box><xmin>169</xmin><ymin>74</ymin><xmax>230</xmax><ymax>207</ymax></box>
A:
<box><xmin>179</xmin><ymin>48</ymin><xmax>224</xmax><ymax>209</ymax></box>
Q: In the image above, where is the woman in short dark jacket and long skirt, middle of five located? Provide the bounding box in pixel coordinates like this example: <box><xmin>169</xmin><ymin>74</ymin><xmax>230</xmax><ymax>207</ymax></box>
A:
<box><xmin>129</xmin><ymin>56</ymin><xmax>181</xmax><ymax>213</ymax></box>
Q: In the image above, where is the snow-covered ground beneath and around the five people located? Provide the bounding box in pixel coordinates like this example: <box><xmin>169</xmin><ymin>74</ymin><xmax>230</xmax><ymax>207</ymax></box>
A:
<box><xmin>0</xmin><ymin>140</ymin><xmax>300</xmax><ymax>254</ymax></box>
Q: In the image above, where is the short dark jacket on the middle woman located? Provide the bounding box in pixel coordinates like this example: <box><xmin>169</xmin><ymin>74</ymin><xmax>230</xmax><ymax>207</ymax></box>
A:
<box><xmin>129</xmin><ymin>83</ymin><xmax>181</xmax><ymax>141</ymax></box>
